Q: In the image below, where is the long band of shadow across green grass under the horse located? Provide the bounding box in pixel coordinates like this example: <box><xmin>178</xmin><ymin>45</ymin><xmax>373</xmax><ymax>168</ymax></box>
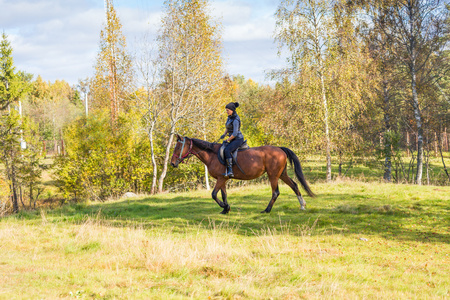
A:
<box><xmin>15</xmin><ymin>191</ymin><xmax>450</xmax><ymax>243</ymax></box>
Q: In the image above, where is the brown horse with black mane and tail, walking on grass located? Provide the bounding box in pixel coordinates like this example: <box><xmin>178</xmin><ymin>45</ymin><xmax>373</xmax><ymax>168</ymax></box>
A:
<box><xmin>170</xmin><ymin>135</ymin><xmax>315</xmax><ymax>214</ymax></box>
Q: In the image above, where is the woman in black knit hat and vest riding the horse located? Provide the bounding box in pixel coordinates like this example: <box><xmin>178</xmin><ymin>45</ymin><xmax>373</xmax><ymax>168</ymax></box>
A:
<box><xmin>220</xmin><ymin>102</ymin><xmax>244</xmax><ymax>178</ymax></box>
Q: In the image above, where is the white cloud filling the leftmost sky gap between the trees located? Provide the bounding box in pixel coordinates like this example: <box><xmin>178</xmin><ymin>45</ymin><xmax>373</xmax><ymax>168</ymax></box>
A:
<box><xmin>2</xmin><ymin>1</ymin><xmax>103</xmax><ymax>84</ymax></box>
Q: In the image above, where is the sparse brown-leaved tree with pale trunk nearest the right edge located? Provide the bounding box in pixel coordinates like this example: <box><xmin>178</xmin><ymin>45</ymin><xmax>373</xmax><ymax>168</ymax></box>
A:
<box><xmin>385</xmin><ymin>0</ymin><xmax>448</xmax><ymax>185</ymax></box>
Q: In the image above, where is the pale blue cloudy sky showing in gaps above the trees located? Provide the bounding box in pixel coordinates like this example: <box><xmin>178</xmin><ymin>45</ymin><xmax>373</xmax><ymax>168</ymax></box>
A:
<box><xmin>0</xmin><ymin>0</ymin><xmax>285</xmax><ymax>85</ymax></box>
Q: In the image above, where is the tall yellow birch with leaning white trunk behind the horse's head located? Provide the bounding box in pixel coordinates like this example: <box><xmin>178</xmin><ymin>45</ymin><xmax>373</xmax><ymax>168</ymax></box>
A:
<box><xmin>158</xmin><ymin>0</ymin><xmax>223</xmax><ymax>192</ymax></box>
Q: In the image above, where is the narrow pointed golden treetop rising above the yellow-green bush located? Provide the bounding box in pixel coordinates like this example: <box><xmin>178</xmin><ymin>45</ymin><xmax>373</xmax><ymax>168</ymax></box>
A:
<box><xmin>91</xmin><ymin>0</ymin><xmax>132</xmax><ymax>128</ymax></box>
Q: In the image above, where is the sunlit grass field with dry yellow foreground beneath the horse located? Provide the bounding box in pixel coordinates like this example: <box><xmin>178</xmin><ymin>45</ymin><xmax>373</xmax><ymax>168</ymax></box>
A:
<box><xmin>0</xmin><ymin>181</ymin><xmax>450</xmax><ymax>299</ymax></box>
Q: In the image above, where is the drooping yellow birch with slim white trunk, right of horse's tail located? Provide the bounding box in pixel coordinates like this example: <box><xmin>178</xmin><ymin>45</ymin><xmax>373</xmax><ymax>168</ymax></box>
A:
<box><xmin>275</xmin><ymin>0</ymin><xmax>367</xmax><ymax>181</ymax></box>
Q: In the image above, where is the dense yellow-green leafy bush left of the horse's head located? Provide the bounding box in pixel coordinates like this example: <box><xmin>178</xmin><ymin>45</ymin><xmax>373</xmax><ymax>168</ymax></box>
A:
<box><xmin>55</xmin><ymin>111</ymin><xmax>156</xmax><ymax>200</ymax></box>
